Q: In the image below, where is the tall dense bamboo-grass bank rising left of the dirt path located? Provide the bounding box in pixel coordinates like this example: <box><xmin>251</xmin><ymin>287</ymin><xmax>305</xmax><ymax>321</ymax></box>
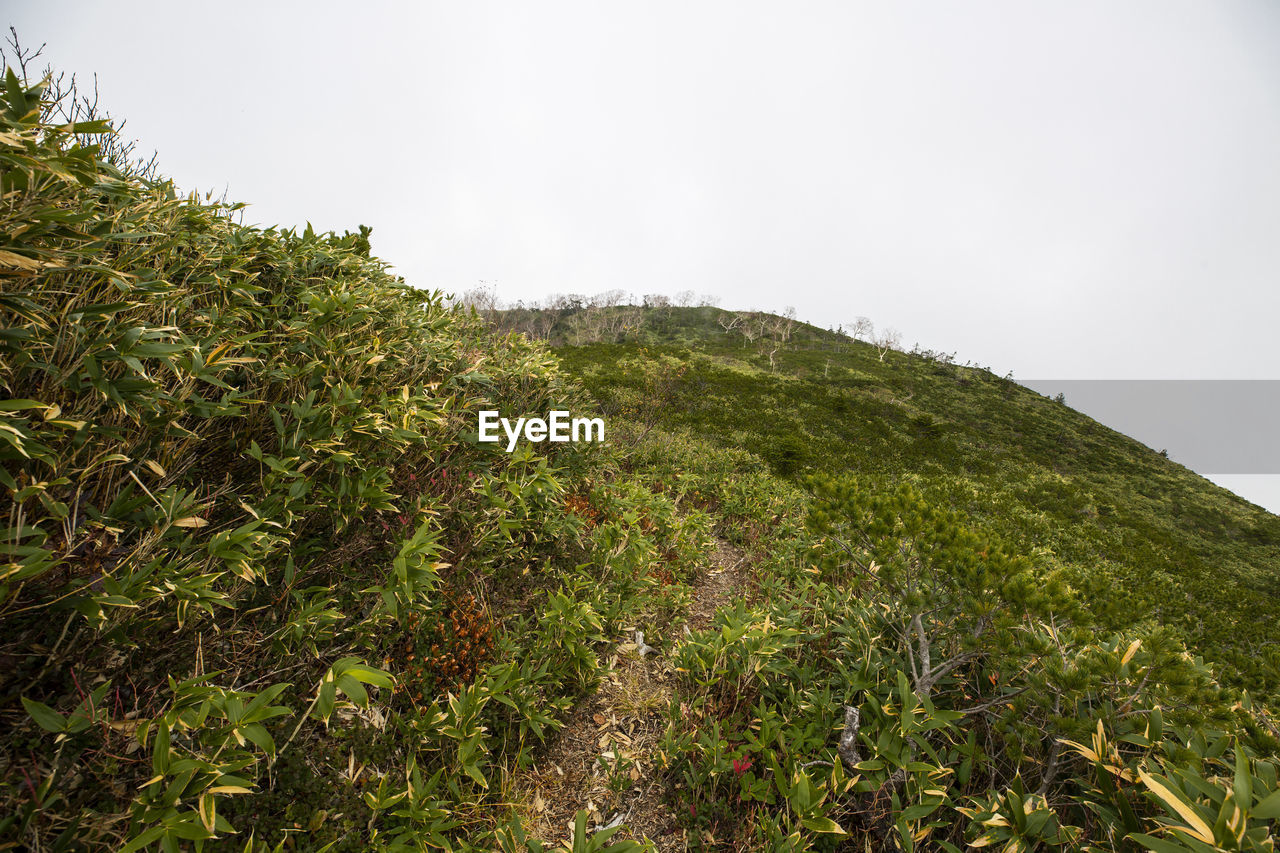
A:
<box><xmin>0</xmin><ymin>72</ymin><xmax>708</xmax><ymax>850</ymax></box>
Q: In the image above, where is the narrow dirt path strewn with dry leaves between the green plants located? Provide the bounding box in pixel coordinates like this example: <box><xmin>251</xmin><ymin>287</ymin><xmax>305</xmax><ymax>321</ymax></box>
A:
<box><xmin>516</xmin><ymin>539</ymin><xmax>746</xmax><ymax>853</ymax></box>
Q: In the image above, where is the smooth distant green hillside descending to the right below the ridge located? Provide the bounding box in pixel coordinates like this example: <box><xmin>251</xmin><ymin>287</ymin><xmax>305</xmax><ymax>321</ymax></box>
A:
<box><xmin>558</xmin><ymin>307</ymin><xmax>1280</xmax><ymax>699</ymax></box>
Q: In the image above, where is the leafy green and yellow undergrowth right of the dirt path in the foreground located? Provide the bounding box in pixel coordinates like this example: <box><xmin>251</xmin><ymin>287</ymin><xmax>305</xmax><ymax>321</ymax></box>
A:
<box><xmin>611</xmin><ymin>433</ymin><xmax>1280</xmax><ymax>852</ymax></box>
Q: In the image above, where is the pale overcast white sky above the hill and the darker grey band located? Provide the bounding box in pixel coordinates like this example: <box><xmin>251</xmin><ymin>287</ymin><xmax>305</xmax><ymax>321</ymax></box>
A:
<box><xmin>8</xmin><ymin>0</ymin><xmax>1280</xmax><ymax>504</ymax></box>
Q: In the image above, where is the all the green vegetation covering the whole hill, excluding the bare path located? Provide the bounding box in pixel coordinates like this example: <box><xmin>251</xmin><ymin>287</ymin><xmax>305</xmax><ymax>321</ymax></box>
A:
<box><xmin>0</xmin><ymin>64</ymin><xmax>1280</xmax><ymax>853</ymax></box>
